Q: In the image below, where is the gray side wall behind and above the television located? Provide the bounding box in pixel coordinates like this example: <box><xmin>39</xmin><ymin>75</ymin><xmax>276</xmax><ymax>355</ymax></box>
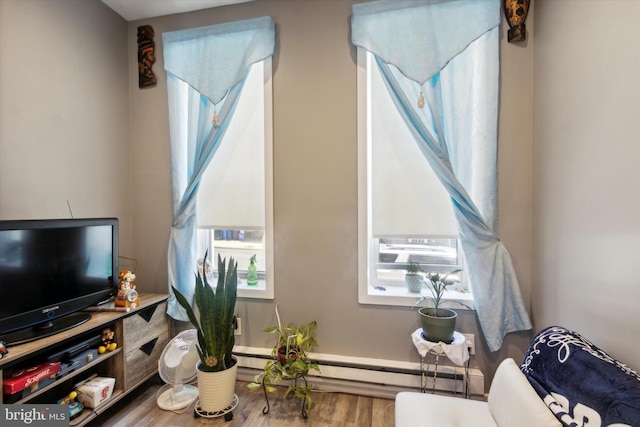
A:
<box><xmin>0</xmin><ymin>0</ymin><xmax>132</xmax><ymax>254</ymax></box>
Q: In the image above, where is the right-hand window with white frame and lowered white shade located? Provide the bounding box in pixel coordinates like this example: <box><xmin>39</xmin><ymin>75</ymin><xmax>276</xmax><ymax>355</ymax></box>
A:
<box><xmin>358</xmin><ymin>48</ymin><xmax>471</xmax><ymax>306</ymax></box>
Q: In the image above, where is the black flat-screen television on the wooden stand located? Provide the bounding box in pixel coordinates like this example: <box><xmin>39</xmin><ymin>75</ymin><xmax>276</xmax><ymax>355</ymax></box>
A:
<box><xmin>0</xmin><ymin>218</ymin><xmax>118</xmax><ymax>345</ymax></box>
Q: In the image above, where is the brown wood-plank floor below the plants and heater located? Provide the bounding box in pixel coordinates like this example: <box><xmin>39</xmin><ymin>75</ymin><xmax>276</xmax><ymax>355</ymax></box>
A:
<box><xmin>88</xmin><ymin>379</ymin><xmax>395</xmax><ymax>427</ymax></box>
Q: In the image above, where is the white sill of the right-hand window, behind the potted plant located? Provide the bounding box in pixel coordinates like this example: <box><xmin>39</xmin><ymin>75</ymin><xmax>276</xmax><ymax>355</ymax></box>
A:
<box><xmin>358</xmin><ymin>286</ymin><xmax>475</xmax><ymax>310</ymax></box>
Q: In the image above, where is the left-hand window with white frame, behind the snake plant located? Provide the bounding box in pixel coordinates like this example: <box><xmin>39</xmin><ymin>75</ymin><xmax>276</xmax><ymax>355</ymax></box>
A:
<box><xmin>197</xmin><ymin>58</ymin><xmax>273</xmax><ymax>298</ymax></box>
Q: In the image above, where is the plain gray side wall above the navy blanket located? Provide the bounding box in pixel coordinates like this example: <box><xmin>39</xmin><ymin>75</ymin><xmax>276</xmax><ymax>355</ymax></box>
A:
<box><xmin>532</xmin><ymin>0</ymin><xmax>640</xmax><ymax>370</ymax></box>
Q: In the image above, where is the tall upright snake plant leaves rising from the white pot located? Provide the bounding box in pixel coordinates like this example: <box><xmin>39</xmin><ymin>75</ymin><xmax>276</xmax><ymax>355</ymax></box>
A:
<box><xmin>172</xmin><ymin>253</ymin><xmax>238</xmax><ymax>372</ymax></box>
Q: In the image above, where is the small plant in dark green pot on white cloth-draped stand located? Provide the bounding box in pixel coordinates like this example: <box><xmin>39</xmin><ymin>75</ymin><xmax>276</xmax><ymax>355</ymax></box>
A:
<box><xmin>418</xmin><ymin>270</ymin><xmax>461</xmax><ymax>344</ymax></box>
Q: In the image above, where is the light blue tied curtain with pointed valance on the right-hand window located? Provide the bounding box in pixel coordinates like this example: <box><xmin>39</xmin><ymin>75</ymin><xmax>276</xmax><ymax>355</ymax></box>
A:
<box><xmin>352</xmin><ymin>0</ymin><xmax>531</xmax><ymax>351</ymax></box>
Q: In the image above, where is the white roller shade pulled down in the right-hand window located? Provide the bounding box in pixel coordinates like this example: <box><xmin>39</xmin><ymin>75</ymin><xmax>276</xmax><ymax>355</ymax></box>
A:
<box><xmin>368</xmin><ymin>52</ymin><xmax>458</xmax><ymax>238</ymax></box>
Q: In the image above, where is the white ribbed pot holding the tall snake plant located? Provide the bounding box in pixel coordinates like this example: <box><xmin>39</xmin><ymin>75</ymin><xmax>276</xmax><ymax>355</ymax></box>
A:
<box><xmin>198</xmin><ymin>356</ymin><xmax>238</xmax><ymax>412</ymax></box>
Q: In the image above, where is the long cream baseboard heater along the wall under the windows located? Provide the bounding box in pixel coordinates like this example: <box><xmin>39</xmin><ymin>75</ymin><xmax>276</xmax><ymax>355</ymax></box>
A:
<box><xmin>233</xmin><ymin>346</ymin><xmax>484</xmax><ymax>399</ymax></box>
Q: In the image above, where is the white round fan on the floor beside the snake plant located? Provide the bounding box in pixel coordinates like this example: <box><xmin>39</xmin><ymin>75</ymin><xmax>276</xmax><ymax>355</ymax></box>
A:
<box><xmin>157</xmin><ymin>329</ymin><xmax>199</xmax><ymax>411</ymax></box>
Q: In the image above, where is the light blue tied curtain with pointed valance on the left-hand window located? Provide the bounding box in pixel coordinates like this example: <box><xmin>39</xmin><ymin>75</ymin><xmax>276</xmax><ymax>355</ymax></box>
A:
<box><xmin>162</xmin><ymin>17</ymin><xmax>275</xmax><ymax>320</ymax></box>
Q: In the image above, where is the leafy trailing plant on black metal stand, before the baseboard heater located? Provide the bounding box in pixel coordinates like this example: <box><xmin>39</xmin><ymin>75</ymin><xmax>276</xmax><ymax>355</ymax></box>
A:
<box><xmin>247</xmin><ymin>320</ymin><xmax>319</xmax><ymax>418</ymax></box>
